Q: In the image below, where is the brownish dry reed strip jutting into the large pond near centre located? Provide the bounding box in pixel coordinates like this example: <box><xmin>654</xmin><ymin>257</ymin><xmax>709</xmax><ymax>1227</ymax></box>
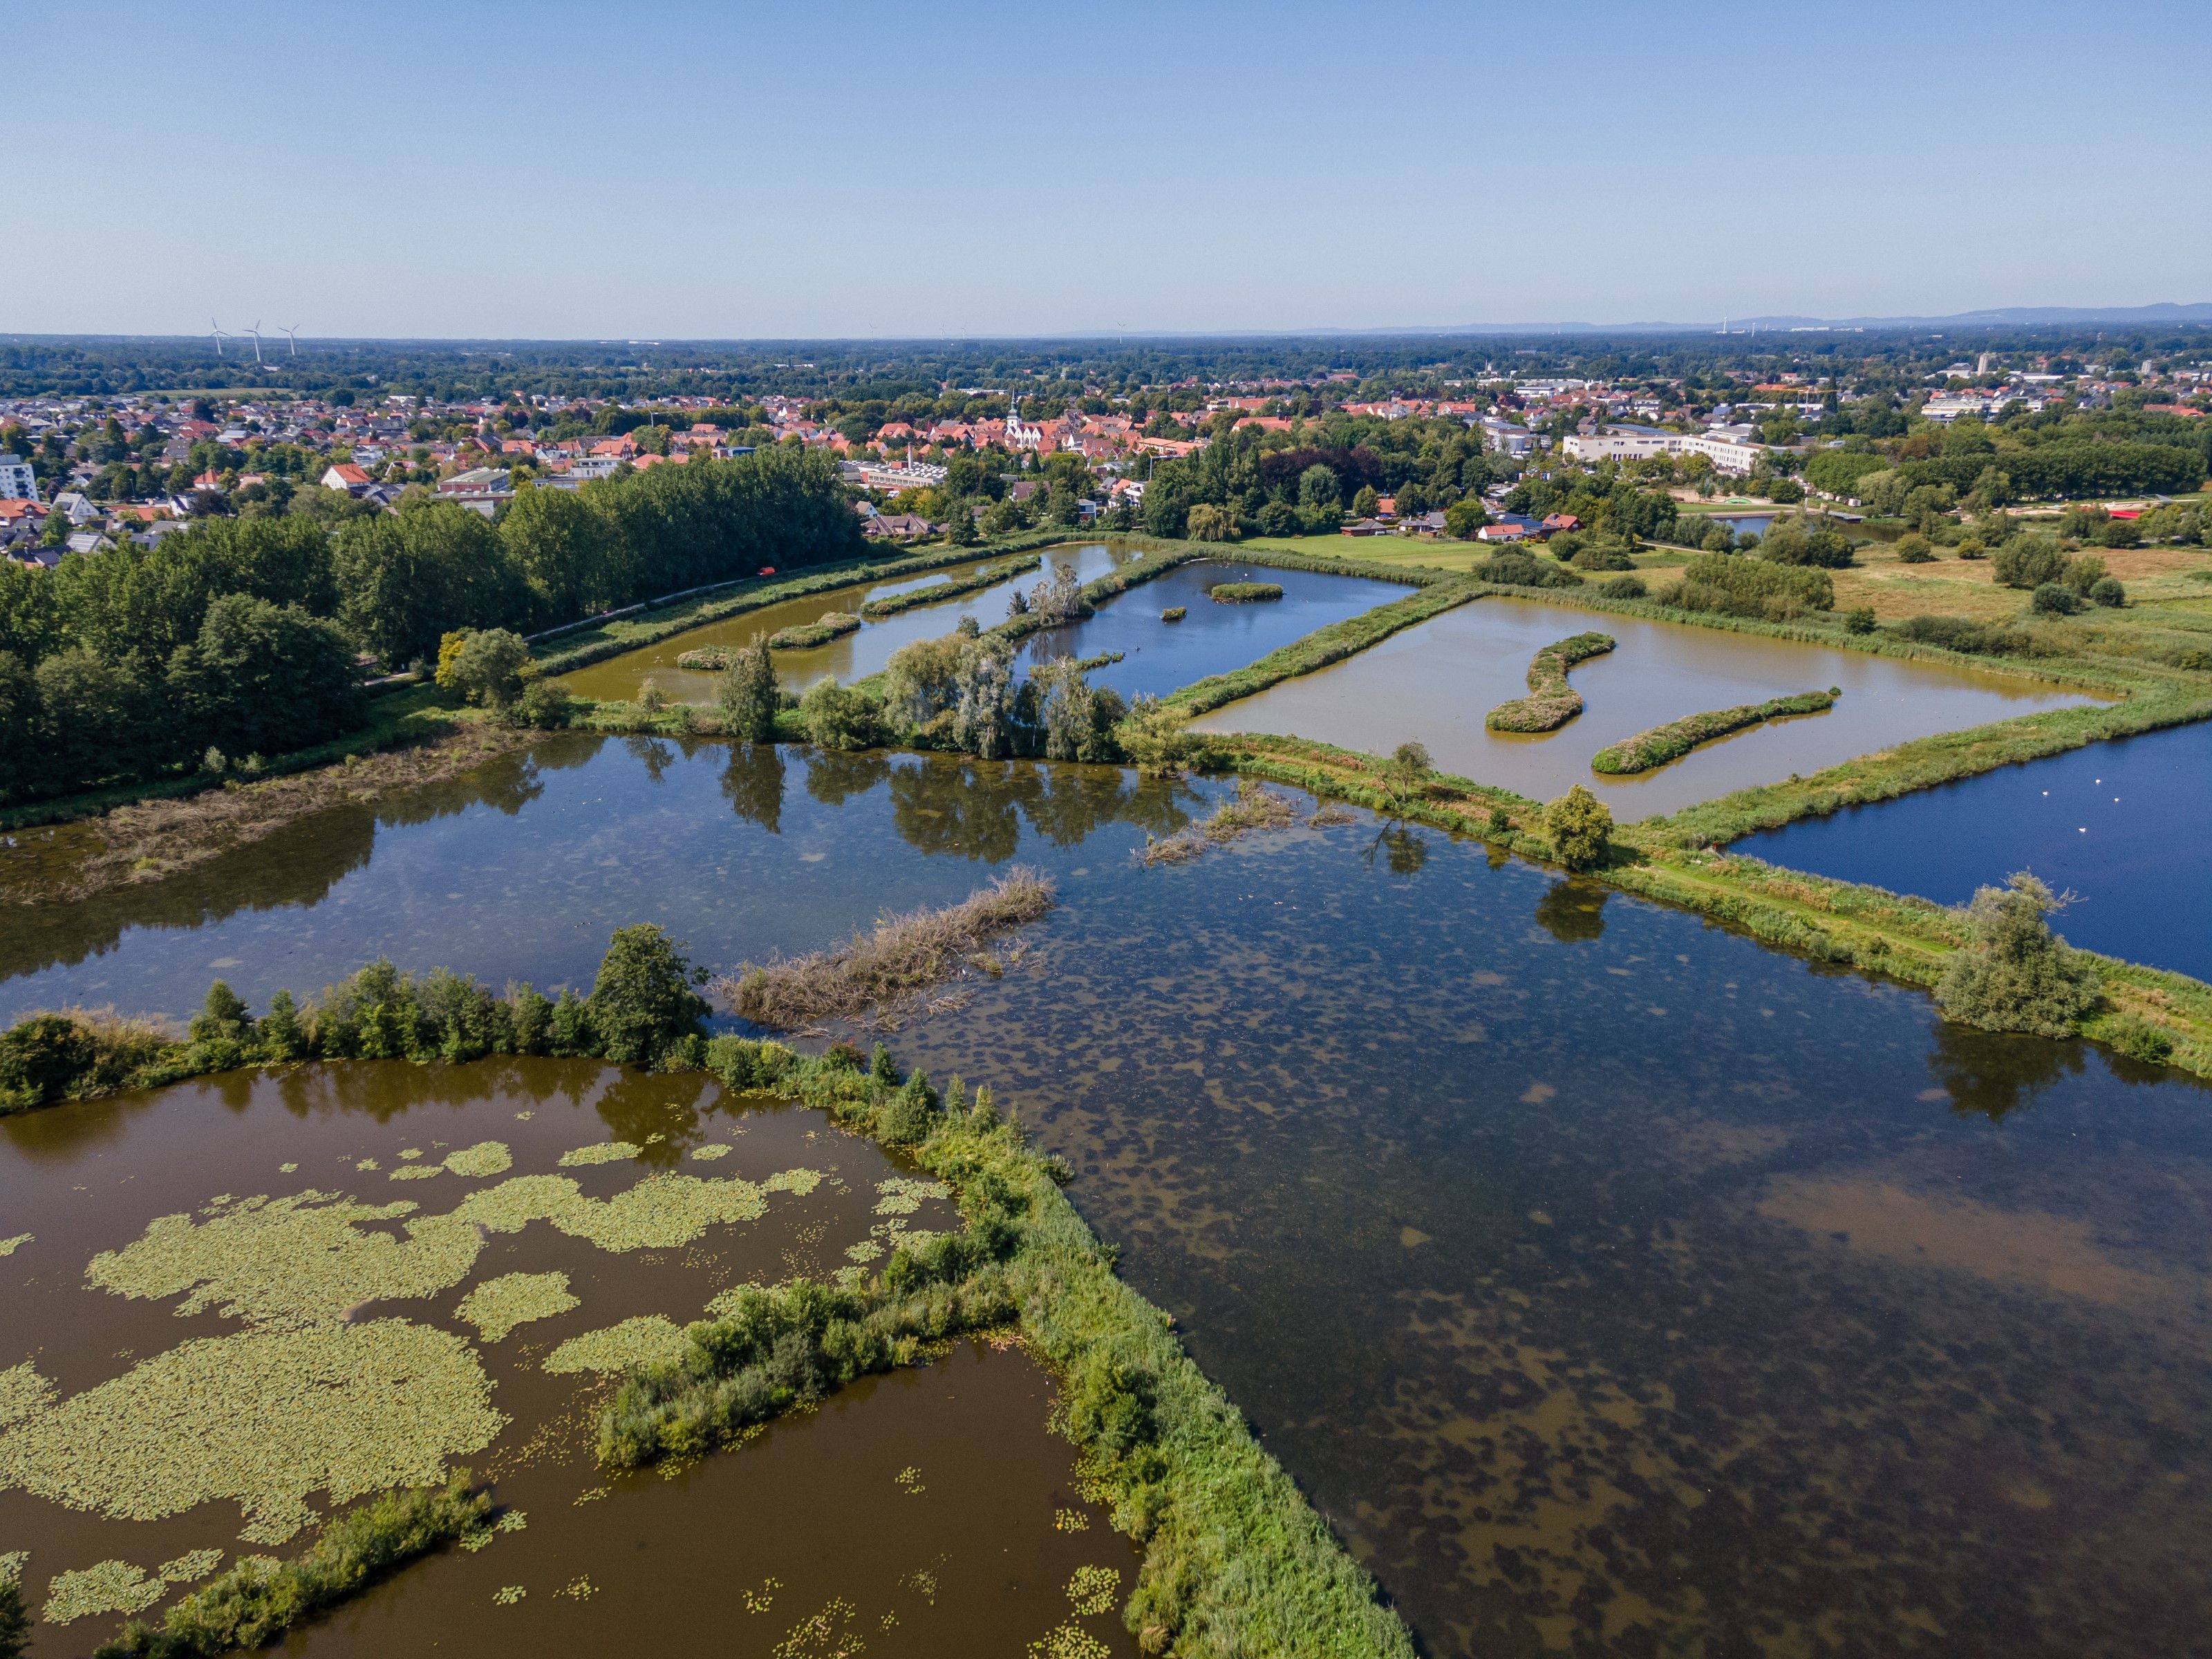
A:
<box><xmin>721</xmin><ymin>865</ymin><xmax>1053</xmax><ymax>1031</ymax></box>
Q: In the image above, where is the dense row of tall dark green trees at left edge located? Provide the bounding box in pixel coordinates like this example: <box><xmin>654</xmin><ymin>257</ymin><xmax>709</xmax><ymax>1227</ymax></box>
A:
<box><xmin>0</xmin><ymin>449</ymin><xmax>865</xmax><ymax>803</ymax></box>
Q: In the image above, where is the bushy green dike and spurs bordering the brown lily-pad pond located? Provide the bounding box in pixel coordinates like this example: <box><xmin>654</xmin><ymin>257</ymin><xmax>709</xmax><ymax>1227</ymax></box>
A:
<box><xmin>0</xmin><ymin>927</ymin><xmax>1414</xmax><ymax>1659</ymax></box>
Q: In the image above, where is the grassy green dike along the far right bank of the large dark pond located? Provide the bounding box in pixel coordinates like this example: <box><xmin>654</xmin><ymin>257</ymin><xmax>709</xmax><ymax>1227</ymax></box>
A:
<box><xmin>1212</xmin><ymin>732</ymin><xmax>2212</xmax><ymax>1077</ymax></box>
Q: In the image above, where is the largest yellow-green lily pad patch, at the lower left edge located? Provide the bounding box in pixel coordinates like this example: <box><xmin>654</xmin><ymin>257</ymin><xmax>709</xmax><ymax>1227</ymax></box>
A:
<box><xmin>0</xmin><ymin>1318</ymin><xmax>507</xmax><ymax>1544</ymax></box>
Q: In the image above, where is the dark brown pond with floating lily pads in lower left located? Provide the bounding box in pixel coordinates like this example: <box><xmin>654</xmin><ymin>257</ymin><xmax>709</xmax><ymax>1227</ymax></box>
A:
<box><xmin>0</xmin><ymin>1062</ymin><xmax>1135</xmax><ymax>1655</ymax></box>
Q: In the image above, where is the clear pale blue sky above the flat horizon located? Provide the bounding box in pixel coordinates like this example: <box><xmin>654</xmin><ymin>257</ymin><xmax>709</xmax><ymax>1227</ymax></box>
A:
<box><xmin>0</xmin><ymin>0</ymin><xmax>2212</xmax><ymax>339</ymax></box>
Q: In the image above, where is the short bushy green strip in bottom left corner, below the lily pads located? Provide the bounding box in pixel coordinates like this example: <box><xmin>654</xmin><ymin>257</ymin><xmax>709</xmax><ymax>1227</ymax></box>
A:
<box><xmin>95</xmin><ymin>1471</ymin><xmax>489</xmax><ymax>1659</ymax></box>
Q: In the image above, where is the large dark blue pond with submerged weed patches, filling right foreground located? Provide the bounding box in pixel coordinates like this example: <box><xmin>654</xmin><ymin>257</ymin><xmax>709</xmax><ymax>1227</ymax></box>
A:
<box><xmin>0</xmin><ymin>747</ymin><xmax>2212</xmax><ymax>1659</ymax></box>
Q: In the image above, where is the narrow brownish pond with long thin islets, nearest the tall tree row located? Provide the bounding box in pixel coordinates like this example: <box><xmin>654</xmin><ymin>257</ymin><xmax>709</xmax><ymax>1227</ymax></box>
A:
<box><xmin>560</xmin><ymin>542</ymin><xmax>1137</xmax><ymax>704</ymax></box>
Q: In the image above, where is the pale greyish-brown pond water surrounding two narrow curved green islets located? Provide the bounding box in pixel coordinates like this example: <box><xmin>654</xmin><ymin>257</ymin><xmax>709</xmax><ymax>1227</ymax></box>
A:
<box><xmin>1199</xmin><ymin>597</ymin><xmax>2090</xmax><ymax>818</ymax></box>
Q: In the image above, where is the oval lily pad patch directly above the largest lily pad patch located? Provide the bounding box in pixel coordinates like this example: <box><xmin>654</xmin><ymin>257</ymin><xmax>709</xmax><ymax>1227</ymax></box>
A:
<box><xmin>84</xmin><ymin>1190</ymin><xmax>482</xmax><ymax>1325</ymax></box>
